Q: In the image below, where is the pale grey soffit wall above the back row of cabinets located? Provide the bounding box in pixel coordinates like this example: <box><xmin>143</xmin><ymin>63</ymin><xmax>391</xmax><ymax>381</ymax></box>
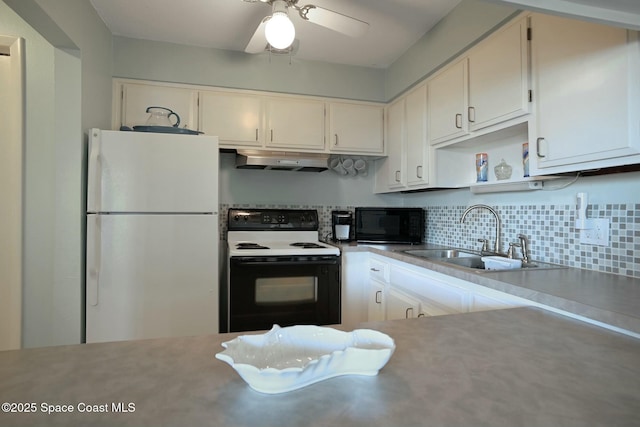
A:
<box><xmin>113</xmin><ymin>37</ymin><xmax>384</xmax><ymax>101</ymax></box>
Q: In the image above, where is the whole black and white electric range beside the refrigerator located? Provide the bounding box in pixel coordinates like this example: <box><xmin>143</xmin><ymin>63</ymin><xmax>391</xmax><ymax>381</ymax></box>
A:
<box><xmin>220</xmin><ymin>208</ymin><xmax>341</xmax><ymax>332</ymax></box>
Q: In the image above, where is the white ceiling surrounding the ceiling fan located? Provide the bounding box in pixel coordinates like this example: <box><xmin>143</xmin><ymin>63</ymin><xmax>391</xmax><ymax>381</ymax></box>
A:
<box><xmin>91</xmin><ymin>0</ymin><xmax>640</xmax><ymax>68</ymax></box>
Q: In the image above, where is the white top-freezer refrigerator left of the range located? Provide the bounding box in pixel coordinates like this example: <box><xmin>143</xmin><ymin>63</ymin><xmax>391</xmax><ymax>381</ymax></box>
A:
<box><xmin>85</xmin><ymin>129</ymin><xmax>219</xmax><ymax>343</ymax></box>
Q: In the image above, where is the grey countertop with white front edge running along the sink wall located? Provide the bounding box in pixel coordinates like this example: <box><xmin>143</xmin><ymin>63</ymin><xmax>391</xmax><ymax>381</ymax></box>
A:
<box><xmin>338</xmin><ymin>243</ymin><xmax>640</xmax><ymax>337</ymax></box>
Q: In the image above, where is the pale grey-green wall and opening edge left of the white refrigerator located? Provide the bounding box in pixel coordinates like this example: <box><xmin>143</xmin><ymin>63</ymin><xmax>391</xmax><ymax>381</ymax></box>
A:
<box><xmin>0</xmin><ymin>0</ymin><xmax>112</xmax><ymax>347</ymax></box>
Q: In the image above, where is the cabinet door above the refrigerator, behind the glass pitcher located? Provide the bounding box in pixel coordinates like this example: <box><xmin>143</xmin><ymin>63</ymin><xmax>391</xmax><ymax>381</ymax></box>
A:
<box><xmin>120</xmin><ymin>83</ymin><xmax>198</xmax><ymax>130</ymax></box>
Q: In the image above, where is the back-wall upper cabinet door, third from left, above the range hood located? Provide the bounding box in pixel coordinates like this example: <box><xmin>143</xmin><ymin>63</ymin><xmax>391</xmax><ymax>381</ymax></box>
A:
<box><xmin>266</xmin><ymin>98</ymin><xmax>324</xmax><ymax>150</ymax></box>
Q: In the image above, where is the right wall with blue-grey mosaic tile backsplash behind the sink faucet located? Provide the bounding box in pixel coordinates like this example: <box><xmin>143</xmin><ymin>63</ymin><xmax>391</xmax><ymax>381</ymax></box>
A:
<box><xmin>404</xmin><ymin>172</ymin><xmax>640</xmax><ymax>278</ymax></box>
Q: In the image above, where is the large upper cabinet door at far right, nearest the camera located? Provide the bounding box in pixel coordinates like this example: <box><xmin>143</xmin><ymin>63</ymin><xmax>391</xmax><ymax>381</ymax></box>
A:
<box><xmin>530</xmin><ymin>14</ymin><xmax>640</xmax><ymax>173</ymax></box>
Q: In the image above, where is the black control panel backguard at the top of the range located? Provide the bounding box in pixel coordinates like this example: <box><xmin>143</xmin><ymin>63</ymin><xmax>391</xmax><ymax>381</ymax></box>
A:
<box><xmin>228</xmin><ymin>208</ymin><xmax>318</xmax><ymax>231</ymax></box>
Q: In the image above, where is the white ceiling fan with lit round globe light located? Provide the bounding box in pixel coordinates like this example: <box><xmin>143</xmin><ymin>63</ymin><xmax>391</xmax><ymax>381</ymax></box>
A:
<box><xmin>244</xmin><ymin>0</ymin><xmax>369</xmax><ymax>53</ymax></box>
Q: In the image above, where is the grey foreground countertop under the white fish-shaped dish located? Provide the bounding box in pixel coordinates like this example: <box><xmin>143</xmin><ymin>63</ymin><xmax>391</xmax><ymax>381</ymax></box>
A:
<box><xmin>0</xmin><ymin>307</ymin><xmax>640</xmax><ymax>427</ymax></box>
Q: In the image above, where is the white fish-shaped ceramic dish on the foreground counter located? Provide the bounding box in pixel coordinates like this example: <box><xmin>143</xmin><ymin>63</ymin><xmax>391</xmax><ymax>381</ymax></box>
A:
<box><xmin>216</xmin><ymin>325</ymin><xmax>396</xmax><ymax>394</ymax></box>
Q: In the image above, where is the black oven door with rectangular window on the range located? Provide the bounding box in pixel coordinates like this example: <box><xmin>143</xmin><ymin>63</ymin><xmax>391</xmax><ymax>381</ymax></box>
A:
<box><xmin>228</xmin><ymin>256</ymin><xmax>340</xmax><ymax>332</ymax></box>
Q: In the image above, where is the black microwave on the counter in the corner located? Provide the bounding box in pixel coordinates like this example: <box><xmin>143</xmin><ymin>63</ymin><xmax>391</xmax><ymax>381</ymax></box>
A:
<box><xmin>355</xmin><ymin>208</ymin><xmax>424</xmax><ymax>244</ymax></box>
